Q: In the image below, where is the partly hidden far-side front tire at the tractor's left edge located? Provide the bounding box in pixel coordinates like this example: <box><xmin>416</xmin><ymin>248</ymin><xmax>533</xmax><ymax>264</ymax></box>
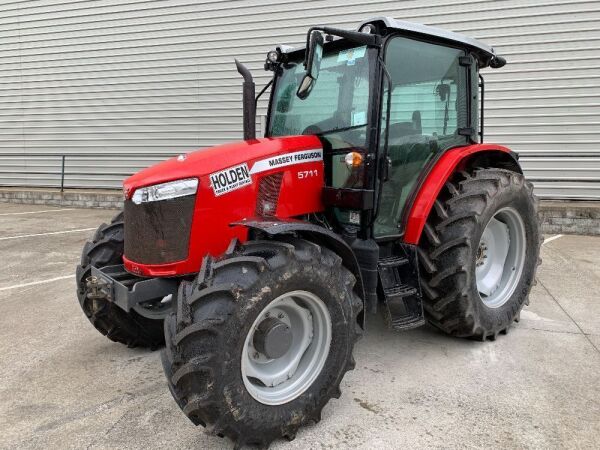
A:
<box><xmin>76</xmin><ymin>212</ymin><xmax>164</xmax><ymax>349</ymax></box>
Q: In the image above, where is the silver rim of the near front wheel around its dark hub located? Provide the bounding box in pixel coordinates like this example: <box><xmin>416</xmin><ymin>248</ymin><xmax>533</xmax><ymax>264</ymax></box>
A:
<box><xmin>241</xmin><ymin>291</ymin><xmax>332</xmax><ymax>405</ymax></box>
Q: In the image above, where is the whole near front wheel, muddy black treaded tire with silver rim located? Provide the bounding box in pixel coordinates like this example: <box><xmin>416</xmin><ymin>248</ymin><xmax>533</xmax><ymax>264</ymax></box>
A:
<box><xmin>162</xmin><ymin>237</ymin><xmax>362</xmax><ymax>447</ymax></box>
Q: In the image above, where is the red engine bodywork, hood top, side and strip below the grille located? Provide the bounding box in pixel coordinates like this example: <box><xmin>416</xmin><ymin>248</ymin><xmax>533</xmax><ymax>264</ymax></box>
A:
<box><xmin>123</xmin><ymin>136</ymin><xmax>324</xmax><ymax>276</ymax></box>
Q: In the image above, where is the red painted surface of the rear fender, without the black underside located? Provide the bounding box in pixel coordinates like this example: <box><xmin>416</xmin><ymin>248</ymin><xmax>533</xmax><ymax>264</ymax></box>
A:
<box><xmin>404</xmin><ymin>144</ymin><xmax>510</xmax><ymax>245</ymax></box>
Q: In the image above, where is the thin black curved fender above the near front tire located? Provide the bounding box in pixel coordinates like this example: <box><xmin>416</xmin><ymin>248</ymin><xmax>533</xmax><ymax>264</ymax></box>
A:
<box><xmin>231</xmin><ymin>217</ymin><xmax>365</xmax><ymax>328</ymax></box>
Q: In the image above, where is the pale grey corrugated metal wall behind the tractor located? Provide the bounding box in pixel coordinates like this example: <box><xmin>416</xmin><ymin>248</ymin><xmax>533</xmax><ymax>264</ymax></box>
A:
<box><xmin>0</xmin><ymin>0</ymin><xmax>600</xmax><ymax>199</ymax></box>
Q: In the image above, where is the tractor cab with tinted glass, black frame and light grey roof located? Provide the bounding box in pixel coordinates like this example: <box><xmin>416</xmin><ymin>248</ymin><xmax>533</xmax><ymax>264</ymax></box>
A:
<box><xmin>265</xmin><ymin>18</ymin><xmax>505</xmax><ymax>239</ymax></box>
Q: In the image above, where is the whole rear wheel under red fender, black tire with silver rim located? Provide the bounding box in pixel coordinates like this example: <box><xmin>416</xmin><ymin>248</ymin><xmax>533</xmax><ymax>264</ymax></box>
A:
<box><xmin>419</xmin><ymin>169</ymin><xmax>542</xmax><ymax>340</ymax></box>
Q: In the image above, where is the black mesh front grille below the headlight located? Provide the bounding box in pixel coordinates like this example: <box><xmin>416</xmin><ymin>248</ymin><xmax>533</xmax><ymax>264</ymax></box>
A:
<box><xmin>125</xmin><ymin>195</ymin><xmax>196</xmax><ymax>264</ymax></box>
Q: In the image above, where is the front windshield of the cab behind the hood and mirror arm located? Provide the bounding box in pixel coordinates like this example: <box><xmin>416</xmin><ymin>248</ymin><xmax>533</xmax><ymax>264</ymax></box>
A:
<box><xmin>270</xmin><ymin>41</ymin><xmax>370</xmax><ymax>148</ymax></box>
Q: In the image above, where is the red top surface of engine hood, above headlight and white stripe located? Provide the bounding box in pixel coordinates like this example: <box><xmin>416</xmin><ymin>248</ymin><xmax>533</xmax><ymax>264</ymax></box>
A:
<box><xmin>123</xmin><ymin>136</ymin><xmax>322</xmax><ymax>199</ymax></box>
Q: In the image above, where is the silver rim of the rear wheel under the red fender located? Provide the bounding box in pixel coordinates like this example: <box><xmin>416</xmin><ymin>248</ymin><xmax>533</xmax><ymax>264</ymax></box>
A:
<box><xmin>475</xmin><ymin>207</ymin><xmax>526</xmax><ymax>308</ymax></box>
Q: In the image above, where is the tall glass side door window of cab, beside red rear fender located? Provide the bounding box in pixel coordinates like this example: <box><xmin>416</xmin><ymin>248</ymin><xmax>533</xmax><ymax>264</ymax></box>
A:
<box><xmin>375</xmin><ymin>36</ymin><xmax>469</xmax><ymax>237</ymax></box>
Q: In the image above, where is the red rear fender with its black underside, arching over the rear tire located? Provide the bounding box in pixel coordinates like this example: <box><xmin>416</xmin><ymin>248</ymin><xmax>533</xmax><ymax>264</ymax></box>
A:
<box><xmin>404</xmin><ymin>144</ymin><xmax>523</xmax><ymax>245</ymax></box>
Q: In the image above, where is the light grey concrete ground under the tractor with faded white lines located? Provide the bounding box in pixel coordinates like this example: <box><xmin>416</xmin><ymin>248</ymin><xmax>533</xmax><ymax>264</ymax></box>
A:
<box><xmin>0</xmin><ymin>203</ymin><xmax>600</xmax><ymax>449</ymax></box>
